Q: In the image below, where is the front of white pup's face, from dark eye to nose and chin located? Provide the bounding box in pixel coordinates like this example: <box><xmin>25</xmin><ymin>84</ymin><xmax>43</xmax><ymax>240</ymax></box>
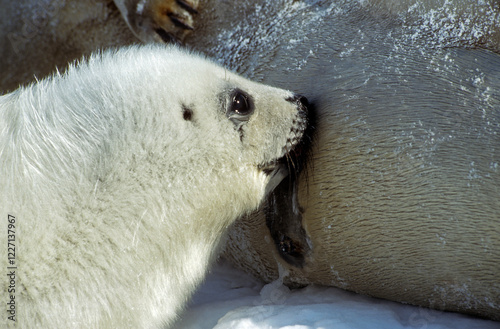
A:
<box><xmin>222</xmin><ymin>86</ymin><xmax>308</xmax><ymax>195</ymax></box>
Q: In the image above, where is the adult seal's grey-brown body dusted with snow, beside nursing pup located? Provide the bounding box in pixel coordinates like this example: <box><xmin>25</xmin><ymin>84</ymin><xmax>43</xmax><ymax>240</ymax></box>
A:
<box><xmin>188</xmin><ymin>1</ymin><xmax>500</xmax><ymax>320</ymax></box>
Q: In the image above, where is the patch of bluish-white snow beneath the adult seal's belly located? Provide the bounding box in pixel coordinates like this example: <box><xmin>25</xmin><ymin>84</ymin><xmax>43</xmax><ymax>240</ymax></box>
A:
<box><xmin>175</xmin><ymin>262</ymin><xmax>500</xmax><ymax>329</ymax></box>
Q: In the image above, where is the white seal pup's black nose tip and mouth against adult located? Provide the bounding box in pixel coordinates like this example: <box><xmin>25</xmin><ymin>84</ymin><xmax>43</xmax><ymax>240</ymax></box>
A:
<box><xmin>258</xmin><ymin>95</ymin><xmax>309</xmax><ymax>195</ymax></box>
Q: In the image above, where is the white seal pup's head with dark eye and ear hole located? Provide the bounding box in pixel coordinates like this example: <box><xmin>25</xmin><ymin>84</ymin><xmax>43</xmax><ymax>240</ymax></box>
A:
<box><xmin>102</xmin><ymin>46</ymin><xmax>308</xmax><ymax>201</ymax></box>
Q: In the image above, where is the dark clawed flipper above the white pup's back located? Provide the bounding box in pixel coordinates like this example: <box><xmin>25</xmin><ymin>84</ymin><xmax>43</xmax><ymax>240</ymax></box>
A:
<box><xmin>114</xmin><ymin>0</ymin><xmax>199</xmax><ymax>43</ymax></box>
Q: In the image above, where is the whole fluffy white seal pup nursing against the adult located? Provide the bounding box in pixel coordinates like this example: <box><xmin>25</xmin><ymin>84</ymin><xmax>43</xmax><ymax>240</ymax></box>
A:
<box><xmin>0</xmin><ymin>46</ymin><xmax>307</xmax><ymax>328</ymax></box>
